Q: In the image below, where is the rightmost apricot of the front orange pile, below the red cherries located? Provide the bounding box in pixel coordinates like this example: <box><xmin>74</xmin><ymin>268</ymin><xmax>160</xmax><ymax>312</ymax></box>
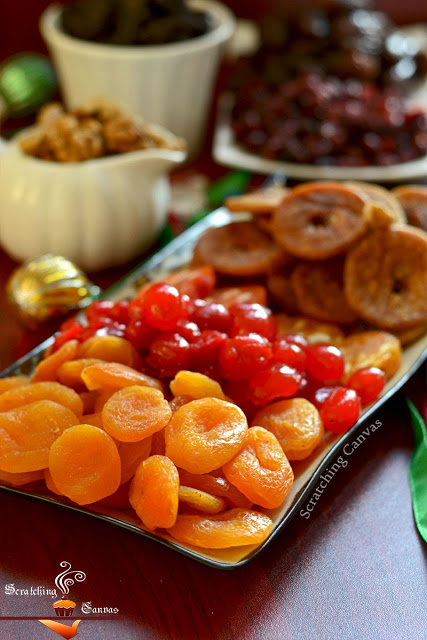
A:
<box><xmin>252</xmin><ymin>398</ymin><xmax>324</xmax><ymax>460</ymax></box>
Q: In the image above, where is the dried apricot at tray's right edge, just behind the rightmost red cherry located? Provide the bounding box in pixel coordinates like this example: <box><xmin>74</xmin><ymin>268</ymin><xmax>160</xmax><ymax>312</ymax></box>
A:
<box><xmin>340</xmin><ymin>331</ymin><xmax>402</xmax><ymax>379</ymax></box>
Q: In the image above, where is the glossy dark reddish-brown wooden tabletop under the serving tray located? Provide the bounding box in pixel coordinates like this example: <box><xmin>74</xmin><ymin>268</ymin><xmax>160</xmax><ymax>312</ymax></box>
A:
<box><xmin>0</xmin><ymin>244</ymin><xmax>427</xmax><ymax>640</ymax></box>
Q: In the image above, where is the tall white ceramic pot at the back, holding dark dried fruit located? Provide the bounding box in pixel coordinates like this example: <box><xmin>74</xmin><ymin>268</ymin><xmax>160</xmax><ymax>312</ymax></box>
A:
<box><xmin>40</xmin><ymin>0</ymin><xmax>235</xmax><ymax>156</ymax></box>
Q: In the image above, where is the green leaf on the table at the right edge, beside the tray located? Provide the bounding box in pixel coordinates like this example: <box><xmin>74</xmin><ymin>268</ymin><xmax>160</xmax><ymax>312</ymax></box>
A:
<box><xmin>406</xmin><ymin>398</ymin><xmax>427</xmax><ymax>542</ymax></box>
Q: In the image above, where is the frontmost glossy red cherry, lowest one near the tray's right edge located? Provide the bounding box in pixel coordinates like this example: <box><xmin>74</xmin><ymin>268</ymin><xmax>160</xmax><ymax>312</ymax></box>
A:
<box><xmin>320</xmin><ymin>387</ymin><xmax>361</xmax><ymax>433</ymax></box>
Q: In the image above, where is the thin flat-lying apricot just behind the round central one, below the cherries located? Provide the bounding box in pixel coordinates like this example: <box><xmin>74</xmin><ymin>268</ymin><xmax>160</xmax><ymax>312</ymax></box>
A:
<box><xmin>81</xmin><ymin>362</ymin><xmax>163</xmax><ymax>391</ymax></box>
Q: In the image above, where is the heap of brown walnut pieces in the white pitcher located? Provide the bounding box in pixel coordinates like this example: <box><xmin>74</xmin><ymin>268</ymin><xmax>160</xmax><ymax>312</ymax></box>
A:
<box><xmin>20</xmin><ymin>100</ymin><xmax>185</xmax><ymax>162</ymax></box>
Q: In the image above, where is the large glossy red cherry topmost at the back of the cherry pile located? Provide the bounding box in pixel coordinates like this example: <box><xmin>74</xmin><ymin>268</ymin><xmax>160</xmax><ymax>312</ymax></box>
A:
<box><xmin>141</xmin><ymin>282</ymin><xmax>188</xmax><ymax>331</ymax></box>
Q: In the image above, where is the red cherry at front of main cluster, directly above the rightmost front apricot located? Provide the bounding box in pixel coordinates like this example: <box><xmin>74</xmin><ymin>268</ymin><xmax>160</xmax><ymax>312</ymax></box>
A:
<box><xmin>250</xmin><ymin>364</ymin><xmax>301</xmax><ymax>405</ymax></box>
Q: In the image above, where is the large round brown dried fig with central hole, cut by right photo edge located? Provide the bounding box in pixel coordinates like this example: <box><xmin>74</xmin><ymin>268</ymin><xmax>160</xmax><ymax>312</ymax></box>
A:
<box><xmin>344</xmin><ymin>225</ymin><xmax>427</xmax><ymax>331</ymax></box>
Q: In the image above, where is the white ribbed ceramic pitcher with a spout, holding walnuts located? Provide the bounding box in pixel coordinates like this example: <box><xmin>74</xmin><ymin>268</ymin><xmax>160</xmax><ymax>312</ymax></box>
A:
<box><xmin>0</xmin><ymin>128</ymin><xmax>186</xmax><ymax>271</ymax></box>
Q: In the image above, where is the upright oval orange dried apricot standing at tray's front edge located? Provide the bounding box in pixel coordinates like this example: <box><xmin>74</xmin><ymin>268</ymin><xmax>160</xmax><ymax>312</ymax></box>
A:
<box><xmin>129</xmin><ymin>456</ymin><xmax>179</xmax><ymax>529</ymax></box>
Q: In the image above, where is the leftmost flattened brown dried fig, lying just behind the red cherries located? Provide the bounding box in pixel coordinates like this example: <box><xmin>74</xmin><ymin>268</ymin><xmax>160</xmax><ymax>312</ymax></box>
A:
<box><xmin>194</xmin><ymin>222</ymin><xmax>280</xmax><ymax>276</ymax></box>
